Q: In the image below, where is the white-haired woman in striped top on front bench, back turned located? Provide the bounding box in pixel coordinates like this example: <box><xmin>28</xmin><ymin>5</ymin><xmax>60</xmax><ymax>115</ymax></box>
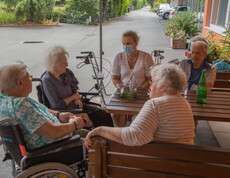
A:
<box><xmin>85</xmin><ymin>64</ymin><xmax>194</xmax><ymax>148</ymax></box>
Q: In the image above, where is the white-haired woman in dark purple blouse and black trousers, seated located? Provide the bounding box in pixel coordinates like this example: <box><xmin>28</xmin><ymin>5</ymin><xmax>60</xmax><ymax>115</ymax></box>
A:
<box><xmin>42</xmin><ymin>46</ymin><xmax>113</xmax><ymax>127</ymax></box>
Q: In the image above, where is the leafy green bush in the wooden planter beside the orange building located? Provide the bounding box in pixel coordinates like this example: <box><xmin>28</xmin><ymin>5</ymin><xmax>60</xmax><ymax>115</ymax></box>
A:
<box><xmin>164</xmin><ymin>11</ymin><xmax>200</xmax><ymax>37</ymax></box>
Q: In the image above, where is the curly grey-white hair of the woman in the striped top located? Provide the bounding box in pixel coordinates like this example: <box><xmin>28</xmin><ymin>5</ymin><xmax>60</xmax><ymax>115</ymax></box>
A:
<box><xmin>151</xmin><ymin>64</ymin><xmax>187</xmax><ymax>92</ymax></box>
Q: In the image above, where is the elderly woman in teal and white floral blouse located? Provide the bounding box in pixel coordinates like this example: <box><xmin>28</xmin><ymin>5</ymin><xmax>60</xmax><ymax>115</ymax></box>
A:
<box><xmin>0</xmin><ymin>62</ymin><xmax>84</xmax><ymax>149</ymax></box>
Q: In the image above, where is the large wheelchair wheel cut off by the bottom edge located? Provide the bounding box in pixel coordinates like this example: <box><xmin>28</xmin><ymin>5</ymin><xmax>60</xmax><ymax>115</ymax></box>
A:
<box><xmin>16</xmin><ymin>162</ymin><xmax>78</xmax><ymax>178</ymax></box>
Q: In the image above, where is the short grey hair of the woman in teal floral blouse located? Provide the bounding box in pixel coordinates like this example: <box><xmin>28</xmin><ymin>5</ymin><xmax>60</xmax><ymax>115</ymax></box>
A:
<box><xmin>0</xmin><ymin>61</ymin><xmax>27</xmax><ymax>92</ymax></box>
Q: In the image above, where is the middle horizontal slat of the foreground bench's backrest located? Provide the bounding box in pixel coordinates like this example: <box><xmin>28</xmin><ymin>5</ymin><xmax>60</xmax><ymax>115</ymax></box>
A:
<box><xmin>107</xmin><ymin>153</ymin><xmax>230</xmax><ymax>177</ymax></box>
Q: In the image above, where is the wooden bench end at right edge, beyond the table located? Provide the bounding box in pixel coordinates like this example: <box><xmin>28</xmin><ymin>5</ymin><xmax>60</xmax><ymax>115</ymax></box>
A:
<box><xmin>212</xmin><ymin>72</ymin><xmax>230</xmax><ymax>91</ymax></box>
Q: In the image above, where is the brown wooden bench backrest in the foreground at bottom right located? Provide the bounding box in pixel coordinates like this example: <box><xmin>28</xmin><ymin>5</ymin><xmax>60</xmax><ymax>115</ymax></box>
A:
<box><xmin>89</xmin><ymin>137</ymin><xmax>230</xmax><ymax>178</ymax></box>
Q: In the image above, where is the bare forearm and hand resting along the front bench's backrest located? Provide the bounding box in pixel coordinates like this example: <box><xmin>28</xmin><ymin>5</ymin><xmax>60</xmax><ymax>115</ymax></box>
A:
<box><xmin>85</xmin><ymin>126</ymin><xmax>124</xmax><ymax>149</ymax></box>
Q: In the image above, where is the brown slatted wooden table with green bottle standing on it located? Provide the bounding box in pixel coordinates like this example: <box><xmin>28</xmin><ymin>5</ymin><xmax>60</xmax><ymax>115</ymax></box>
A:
<box><xmin>106</xmin><ymin>89</ymin><xmax>230</xmax><ymax>127</ymax></box>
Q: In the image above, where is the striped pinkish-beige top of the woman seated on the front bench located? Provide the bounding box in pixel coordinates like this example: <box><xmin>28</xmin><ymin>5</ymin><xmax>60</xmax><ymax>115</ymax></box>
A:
<box><xmin>121</xmin><ymin>94</ymin><xmax>195</xmax><ymax>146</ymax></box>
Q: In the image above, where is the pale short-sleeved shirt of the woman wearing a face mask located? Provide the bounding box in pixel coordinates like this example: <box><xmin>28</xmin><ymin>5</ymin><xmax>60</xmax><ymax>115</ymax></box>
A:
<box><xmin>112</xmin><ymin>51</ymin><xmax>153</xmax><ymax>87</ymax></box>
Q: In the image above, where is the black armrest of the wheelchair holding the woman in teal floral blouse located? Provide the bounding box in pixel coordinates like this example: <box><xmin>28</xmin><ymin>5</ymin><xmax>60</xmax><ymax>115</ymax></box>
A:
<box><xmin>27</xmin><ymin>135</ymin><xmax>80</xmax><ymax>158</ymax></box>
